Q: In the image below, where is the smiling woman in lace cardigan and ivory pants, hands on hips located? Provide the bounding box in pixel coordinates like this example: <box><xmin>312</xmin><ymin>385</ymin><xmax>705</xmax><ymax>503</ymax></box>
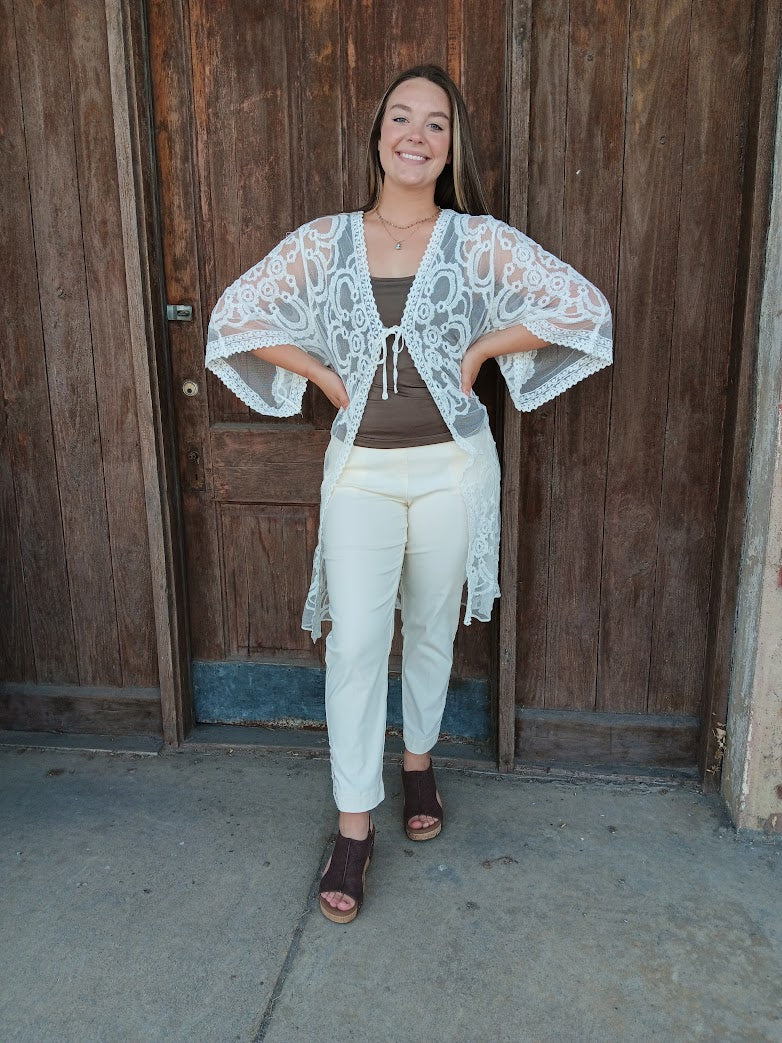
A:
<box><xmin>206</xmin><ymin>66</ymin><xmax>612</xmax><ymax>923</ymax></box>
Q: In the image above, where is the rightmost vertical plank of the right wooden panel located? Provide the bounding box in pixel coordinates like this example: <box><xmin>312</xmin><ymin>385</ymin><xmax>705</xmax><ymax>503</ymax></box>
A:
<box><xmin>649</xmin><ymin>0</ymin><xmax>752</xmax><ymax>713</ymax></box>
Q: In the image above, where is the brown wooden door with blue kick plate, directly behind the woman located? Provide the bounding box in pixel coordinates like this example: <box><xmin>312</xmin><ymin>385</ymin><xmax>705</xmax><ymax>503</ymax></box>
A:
<box><xmin>149</xmin><ymin>0</ymin><xmax>505</xmax><ymax>738</ymax></box>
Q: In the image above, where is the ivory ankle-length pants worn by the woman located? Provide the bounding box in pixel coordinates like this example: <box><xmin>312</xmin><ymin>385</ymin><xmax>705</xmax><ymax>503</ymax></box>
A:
<box><xmin>322</xmin><ymin>441</ymin><xmax>468</xmax><ymax>811</ymax></box>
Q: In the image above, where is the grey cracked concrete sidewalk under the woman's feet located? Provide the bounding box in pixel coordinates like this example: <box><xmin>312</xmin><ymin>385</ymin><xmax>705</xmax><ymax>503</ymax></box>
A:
<box><xmin>0</xmin><ymin>746</ymin><xmax>782</xmax><ymax>1043</ymax></box>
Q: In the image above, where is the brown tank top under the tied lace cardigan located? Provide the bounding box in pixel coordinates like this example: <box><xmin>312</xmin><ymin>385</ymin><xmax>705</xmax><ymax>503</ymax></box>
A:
<box><xmin>353</xmin><ymin>275</ymin><xmax>453</xmax><ymax>450</ymax></box>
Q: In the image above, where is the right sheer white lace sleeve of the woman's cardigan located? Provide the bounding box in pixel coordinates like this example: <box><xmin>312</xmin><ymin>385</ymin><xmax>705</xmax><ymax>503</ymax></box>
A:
<box><xmin>489</xmin><ymin>222</ymin><xmax>613</xmax><ymax>411</ymax></box>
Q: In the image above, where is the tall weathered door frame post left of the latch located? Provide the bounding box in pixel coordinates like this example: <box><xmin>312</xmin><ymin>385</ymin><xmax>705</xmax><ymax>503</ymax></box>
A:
<box><xmin>106</xmin><ymin>0</ymin><xmax>195</xmax><ymax>747</ymax></box>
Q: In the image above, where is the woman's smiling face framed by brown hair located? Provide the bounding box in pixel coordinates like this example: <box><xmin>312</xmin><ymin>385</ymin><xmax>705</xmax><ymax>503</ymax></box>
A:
<box><xmin>377</xmin><ymin>78</ymin><xmax>450</xmax><ymax>193</ymax></box>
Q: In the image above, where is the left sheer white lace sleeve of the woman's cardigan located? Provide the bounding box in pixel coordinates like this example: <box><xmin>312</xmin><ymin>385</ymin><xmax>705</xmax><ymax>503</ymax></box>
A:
<box><xmin>206</xmin><ymin>218</ymin><xmax>331</xmax><ymax>416</ymax></box>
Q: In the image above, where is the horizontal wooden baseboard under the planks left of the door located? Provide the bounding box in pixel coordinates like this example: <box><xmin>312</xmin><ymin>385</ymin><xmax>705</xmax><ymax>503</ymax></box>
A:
<box><xmin>0</xmin><ymin>683</ymin><xmax>162</xmax><ymax>735</ymax></box>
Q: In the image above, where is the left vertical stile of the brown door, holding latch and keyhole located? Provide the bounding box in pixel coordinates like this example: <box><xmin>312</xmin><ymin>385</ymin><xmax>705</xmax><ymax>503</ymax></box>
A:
<box><xmin>147</xmin><ymin>0</ymin><xmax>223</xmax><ymax>659</ymax></box>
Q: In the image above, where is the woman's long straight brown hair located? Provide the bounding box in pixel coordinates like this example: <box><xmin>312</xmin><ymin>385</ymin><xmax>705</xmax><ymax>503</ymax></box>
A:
<box><xmin>362</xmin><ymin>65</ymin><xmax>489</xmax><ymax>214</ymax></box>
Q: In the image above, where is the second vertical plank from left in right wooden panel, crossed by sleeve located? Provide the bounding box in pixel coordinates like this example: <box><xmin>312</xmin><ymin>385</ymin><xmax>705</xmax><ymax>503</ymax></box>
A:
<box><xmin>545</xmin><ymin>0</ymin><xmax>629</xmax><ymax>709</ymax></box>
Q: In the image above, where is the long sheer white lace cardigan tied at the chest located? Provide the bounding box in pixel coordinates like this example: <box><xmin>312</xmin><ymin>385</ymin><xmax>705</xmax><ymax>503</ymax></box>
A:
<box><xmin>206</xmin><ymin>210</ymin><xmax>612</xmax><ymax>640</ymax></box>
